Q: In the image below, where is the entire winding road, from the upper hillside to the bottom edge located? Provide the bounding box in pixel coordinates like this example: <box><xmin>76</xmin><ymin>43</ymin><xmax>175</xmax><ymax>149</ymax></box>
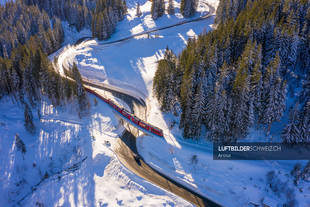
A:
<box><xmin>59</xmin><ymin>3</ymin><xmax>221</xmax><ymax>207</ymax></box>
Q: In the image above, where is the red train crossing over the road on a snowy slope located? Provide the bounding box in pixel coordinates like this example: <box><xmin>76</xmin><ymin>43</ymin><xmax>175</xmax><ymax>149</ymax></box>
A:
<box><xmin>86</xmin><ymin>88</ymin><xmax>163</xmax><ymax>137</ymax></box>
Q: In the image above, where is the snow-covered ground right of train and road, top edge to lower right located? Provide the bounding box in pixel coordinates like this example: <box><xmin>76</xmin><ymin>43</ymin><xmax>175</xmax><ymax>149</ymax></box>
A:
<box><xmin>53</xmin><ymin>0</ymin><xmax>310</xmax><ymax>207</ymax></box>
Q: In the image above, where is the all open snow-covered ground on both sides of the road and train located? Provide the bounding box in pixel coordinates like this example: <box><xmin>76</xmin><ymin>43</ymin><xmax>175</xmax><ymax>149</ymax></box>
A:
<box><xmin>0</xmin><ymin>0</ymin><xmax>310</xmax><ymax>207</ymax></box>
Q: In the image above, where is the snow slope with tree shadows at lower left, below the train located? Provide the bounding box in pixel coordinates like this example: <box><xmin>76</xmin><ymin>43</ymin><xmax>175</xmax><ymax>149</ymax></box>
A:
<box><xmin>0</xmin><ymin>96</ymin><xmax>189</xmax><ymax>207</ymax></box>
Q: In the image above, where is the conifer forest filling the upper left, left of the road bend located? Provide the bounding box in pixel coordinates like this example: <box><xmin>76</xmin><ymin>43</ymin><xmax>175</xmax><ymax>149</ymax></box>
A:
<box><xmin>0</xmin><ymin>0</ymin><xmax>126</xmax><ymax>133</ymax></box>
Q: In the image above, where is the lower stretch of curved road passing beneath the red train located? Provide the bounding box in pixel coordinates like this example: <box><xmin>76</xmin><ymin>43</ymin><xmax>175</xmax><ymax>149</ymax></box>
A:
<box><xmin>84</xmin><ymin>82</ymin><xmax>221</xmax><ymax>207</ymax></box>
